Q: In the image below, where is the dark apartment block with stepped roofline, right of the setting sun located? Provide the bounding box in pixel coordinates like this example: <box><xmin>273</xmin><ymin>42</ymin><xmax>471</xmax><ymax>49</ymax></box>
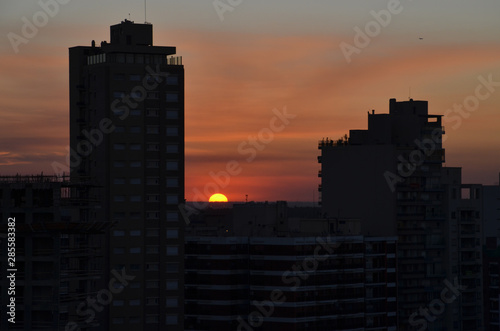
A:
<box><xmin>318</xmin><ymin>99</ymin><xmax>482</xmax><ymax>330</ymax></box>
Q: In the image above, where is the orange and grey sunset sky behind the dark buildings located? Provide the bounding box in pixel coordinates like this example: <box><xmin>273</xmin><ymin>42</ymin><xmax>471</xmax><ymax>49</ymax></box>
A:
<box><xmin>0</xmin><ymin>0</ymin><xmax>500</xmax><ymax>201</ymax></box>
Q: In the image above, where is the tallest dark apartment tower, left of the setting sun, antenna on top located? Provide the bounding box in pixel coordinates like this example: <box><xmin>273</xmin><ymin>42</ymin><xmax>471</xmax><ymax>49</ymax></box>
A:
<box><xmin>69</xmin><ymin>20</ymin><xmax>184</xmax><ymax>331</ymax></box>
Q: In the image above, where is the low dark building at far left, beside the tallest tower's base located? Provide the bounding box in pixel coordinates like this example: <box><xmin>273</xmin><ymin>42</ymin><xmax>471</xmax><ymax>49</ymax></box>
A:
<box><xmin>0</xmin><ymin>175</ymin><xmax>106</xmax><ymax>331</ymax></box>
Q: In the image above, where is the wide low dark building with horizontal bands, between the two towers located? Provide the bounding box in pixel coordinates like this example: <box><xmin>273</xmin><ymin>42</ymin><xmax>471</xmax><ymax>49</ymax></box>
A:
<box><xmin>185</xmin><ymin>201</ymin><xmax>397</xmax><ymax>331</ymax></box>
